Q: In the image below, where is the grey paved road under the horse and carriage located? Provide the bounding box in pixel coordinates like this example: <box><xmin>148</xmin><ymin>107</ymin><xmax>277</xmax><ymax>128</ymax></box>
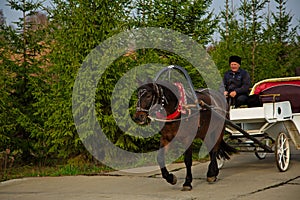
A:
<box><xmin>0</xmin><ymin>151</ymin><xmax>300</xmax><ymax>200</ymax></box>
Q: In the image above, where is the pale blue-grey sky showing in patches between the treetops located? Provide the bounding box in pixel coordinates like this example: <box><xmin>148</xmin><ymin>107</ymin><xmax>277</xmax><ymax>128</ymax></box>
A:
<box><xmin>0</xmin><ymin>0</ymin><xmax>300</xmax><ymax>29</ymax></box>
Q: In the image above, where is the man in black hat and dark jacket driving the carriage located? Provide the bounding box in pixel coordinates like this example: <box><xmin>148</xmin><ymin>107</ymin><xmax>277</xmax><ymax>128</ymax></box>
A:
<box><xmin>223</xmin><ymin>56</ymin><xmax>251</xmax><ymax>107</ymax></box>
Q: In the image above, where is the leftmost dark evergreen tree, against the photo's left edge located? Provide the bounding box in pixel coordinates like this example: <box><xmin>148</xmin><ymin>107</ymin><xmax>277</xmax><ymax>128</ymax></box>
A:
<box><xmin>0</xmin><ymin>0</ymin><xmax>47</xmax><ymax>162</ymax></box>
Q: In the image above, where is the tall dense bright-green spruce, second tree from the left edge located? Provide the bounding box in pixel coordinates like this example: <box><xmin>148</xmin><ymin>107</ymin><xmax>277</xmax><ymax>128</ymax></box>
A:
<box><xmin>36</xmin><ymin>0</ymin><xmax>130</xmax><ymax>158</ymax></box>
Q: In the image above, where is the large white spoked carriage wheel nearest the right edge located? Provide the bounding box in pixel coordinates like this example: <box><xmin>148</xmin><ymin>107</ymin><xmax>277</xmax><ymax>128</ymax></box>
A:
<box><xmin>275</xmin><ymin>133</ymin><xmax>290</xmax><ymax>172</ymax></box>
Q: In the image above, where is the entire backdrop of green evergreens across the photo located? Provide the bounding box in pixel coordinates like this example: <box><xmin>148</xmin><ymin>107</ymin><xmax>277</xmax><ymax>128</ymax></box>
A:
<box><xmin>0</xmin><ymin>0</ymin><xmax>300</xmax><ymax>174</ymax></box>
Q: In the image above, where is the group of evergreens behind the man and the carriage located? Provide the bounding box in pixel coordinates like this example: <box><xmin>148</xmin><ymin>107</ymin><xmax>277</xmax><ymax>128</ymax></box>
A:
<box><xmin>209</xmin><ymin>0</ymin><xmax>299</xmax><ymax>84</ymax></box>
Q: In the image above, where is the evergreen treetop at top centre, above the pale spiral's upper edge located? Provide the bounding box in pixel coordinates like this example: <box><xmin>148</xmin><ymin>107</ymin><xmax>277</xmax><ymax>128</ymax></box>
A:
<box><xmin>135</xmin><ymin>0</ymin><xmax>218</xmax><ymax>45</ymax></box>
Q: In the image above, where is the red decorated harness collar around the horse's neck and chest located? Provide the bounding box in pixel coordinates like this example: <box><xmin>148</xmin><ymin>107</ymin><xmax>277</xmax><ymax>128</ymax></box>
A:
<box><xmin>156</xmin><ymin>82</ymin><xmax>187</xmax><ymax>120</ymax></box>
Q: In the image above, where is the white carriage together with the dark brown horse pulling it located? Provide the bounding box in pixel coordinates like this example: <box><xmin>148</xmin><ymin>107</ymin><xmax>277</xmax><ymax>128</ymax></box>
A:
<box><xmin>134</xmin><ymin>65</ymin><xmax>300</xmax><ymax>190</ymax></box>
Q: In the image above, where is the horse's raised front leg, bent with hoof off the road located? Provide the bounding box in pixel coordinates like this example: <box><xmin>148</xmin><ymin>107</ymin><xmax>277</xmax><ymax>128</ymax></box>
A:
<box><xmin>157</xmin><ymin>142</ymin><xmax>177</xmax><ymax>185</ymax></box>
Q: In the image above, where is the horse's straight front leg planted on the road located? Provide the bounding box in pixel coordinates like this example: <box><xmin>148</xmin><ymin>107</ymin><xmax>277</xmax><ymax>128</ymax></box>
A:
<box><xmin>182</xmin><ymin>146</ymin><xmax>193</xmax><ymax>191</ymax></box>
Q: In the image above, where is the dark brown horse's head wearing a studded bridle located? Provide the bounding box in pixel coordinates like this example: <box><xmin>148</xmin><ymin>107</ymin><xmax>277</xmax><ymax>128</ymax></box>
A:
<box><xmin>134</xmin><ymin>83</ymin><xmax>159</xmax><ymax>124</ymax></box>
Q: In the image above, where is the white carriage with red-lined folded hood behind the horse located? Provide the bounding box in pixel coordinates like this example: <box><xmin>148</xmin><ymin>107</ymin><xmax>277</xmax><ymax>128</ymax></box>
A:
<box><xmin>226</xmin><ymin>77</ymin><xmax>300</xmax><ymax>171</ymax></box>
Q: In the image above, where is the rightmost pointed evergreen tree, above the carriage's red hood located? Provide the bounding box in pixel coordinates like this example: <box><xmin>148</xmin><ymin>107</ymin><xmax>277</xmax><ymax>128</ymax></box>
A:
<box><xmin>257</xmin><ymin>0</ymin><xmax>299</xmax><ymax>80</ymax></box>
